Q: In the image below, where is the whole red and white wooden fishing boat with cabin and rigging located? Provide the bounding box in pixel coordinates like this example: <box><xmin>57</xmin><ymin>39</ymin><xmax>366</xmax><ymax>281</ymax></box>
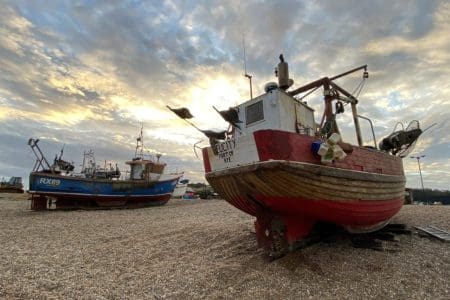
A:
<box><xmin>172</xmin><ymin>55</ymin><xmax>421</xmax><ymax>256</ymax></box>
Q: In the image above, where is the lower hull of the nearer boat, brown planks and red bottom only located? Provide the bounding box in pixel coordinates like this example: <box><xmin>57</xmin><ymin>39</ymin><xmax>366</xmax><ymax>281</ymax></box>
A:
<box><xmin>206</xmin><ymin>161</ymin><xmax>405</xmax><ymax>254</ymax></box>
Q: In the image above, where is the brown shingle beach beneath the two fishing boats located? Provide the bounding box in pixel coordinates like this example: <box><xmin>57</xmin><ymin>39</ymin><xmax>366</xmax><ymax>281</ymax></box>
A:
<box><xmin>0</xmin><ymin>194</ymin><xmax>450</xmax><ymax>299</ymax></box>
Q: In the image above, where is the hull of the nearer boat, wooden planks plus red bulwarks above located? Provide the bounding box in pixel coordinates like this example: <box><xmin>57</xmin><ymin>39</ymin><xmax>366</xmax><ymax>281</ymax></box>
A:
<box><xmin>203</xmin><ymin>130</ymin><xmax>405</xmax><ymax>255</ymax></box>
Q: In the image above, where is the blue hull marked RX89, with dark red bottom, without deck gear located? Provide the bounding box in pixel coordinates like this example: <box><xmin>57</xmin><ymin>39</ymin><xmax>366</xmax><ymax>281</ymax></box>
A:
<box><xmin>29</xmin><ymin>172</ymin><xmax>179</xmax><ymax>209</ymax></box>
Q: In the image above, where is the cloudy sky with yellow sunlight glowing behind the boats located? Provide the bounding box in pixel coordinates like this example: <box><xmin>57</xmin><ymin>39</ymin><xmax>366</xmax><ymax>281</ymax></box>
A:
<box><xmin>0</xmin><ymin>0</ymin><xmax>450</xmax><ymax>190</ymax></box>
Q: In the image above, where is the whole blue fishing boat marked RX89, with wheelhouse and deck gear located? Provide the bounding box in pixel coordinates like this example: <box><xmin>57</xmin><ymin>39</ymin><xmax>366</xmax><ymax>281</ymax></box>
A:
<box><xmin>28</xmin><ymin>130</ymin><xmax>182</xmax><ymax>210</ymax></box>
